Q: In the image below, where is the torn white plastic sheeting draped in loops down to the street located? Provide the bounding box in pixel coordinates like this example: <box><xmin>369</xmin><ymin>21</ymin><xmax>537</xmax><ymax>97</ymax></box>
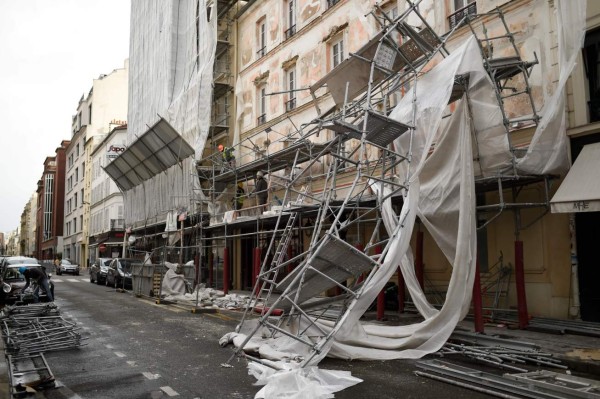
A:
<box><xmin>226</xmin><ymin>1</ymin><xmax>585</xmax><ymax>367</ymax></box>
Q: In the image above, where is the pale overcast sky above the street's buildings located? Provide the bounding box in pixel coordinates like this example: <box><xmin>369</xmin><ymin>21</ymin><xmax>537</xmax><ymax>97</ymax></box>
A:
<box><xmin>0</xmin><ymin>0</ymin><xmax>130</xmax><ymax>233</ymax></box>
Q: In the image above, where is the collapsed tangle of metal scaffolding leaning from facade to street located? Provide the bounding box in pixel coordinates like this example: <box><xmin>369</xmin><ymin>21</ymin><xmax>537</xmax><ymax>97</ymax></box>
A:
<box><xmin>207</xmin><ymin>1</ymin><xmax>584</xmax><ymax>367</ymax></box>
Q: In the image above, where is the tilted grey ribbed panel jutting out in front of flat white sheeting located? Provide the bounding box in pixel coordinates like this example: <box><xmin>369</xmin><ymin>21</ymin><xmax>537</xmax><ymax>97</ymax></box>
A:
<box><xmin>104</xmin><ymin>118</ymin><xmax>194</xmax><ymax>191</ymax></box>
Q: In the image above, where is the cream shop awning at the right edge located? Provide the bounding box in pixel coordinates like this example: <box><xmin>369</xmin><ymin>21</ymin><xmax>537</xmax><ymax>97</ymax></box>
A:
<box><xmin>550</xmin><ymin>143</ymin><xmax>600</xmax><ymax>213</ymax></box>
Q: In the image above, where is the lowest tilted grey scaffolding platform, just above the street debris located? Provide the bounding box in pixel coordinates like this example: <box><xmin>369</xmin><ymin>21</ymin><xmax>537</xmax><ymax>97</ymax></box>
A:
<box><xmin>277</xmin><ymin>234</ymin><xmax>376</xmax><ymax>308</ymax></box>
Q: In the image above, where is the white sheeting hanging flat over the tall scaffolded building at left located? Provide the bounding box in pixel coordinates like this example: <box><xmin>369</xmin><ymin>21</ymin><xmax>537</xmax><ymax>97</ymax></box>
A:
<box><xmin>123</xmin><ymin>0</ymin><xmax>217</xmax><ymax>226</ymax></box>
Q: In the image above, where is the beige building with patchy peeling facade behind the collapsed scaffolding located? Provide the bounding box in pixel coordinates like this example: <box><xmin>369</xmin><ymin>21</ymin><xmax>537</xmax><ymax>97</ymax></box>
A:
<box><xmin>197</xmin><ymin>0</ymin><xmax>599</xmax><ymax>321</ymax></box>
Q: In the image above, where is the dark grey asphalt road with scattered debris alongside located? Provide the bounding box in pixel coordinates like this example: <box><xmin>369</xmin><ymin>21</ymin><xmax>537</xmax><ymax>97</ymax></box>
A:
<box><xmin>36</xmin><ymin>273</ymin><xmax>490</xmax><ymax>399</ymax></box>
